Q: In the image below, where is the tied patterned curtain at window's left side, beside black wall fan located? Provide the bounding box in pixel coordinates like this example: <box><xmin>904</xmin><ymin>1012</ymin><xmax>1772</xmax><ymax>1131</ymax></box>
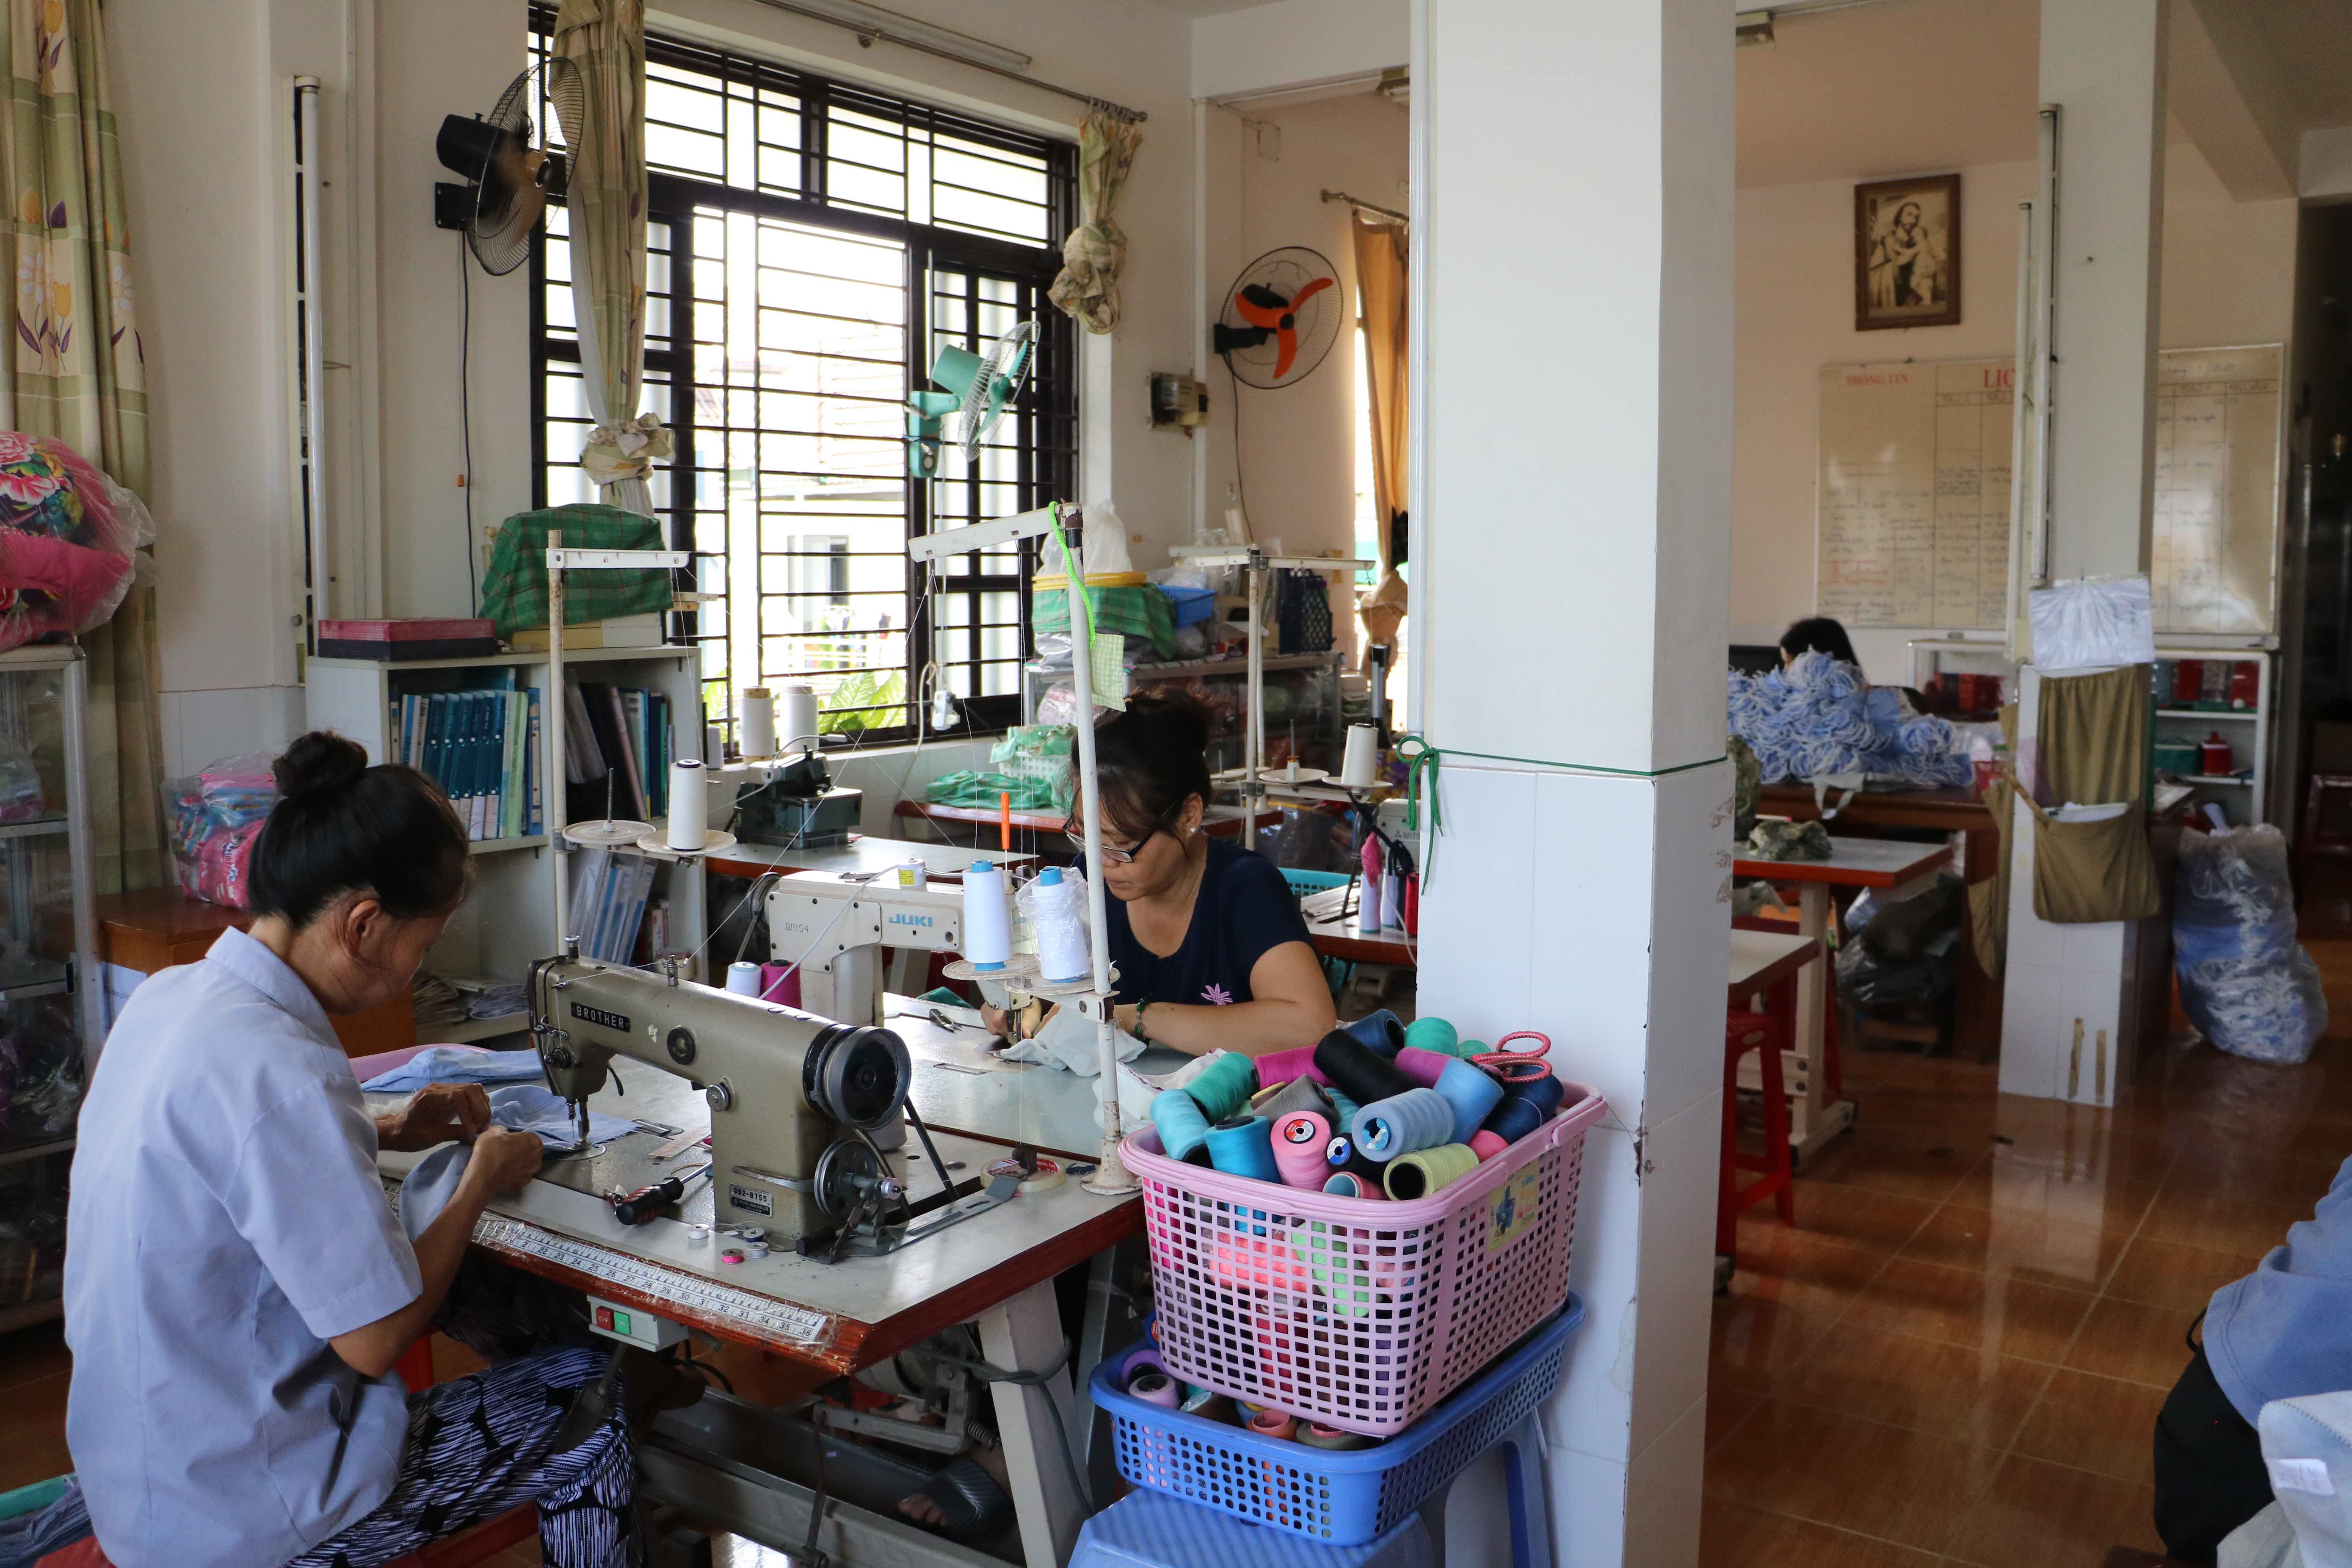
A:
<box><xmin>555</xmin><ymin>0</ymin><xmax>670</xmax><ymax>512</ymax></box>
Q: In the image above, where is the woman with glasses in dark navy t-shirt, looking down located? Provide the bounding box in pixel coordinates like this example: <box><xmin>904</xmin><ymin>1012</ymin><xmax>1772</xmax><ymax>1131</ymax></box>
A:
<box><xmin>988</xmin><ymin>693</ymin><xmax>1336</xmax><ymax>1056</ymax></box>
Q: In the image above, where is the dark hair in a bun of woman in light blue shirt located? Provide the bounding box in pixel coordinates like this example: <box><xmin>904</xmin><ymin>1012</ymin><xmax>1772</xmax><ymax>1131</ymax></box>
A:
<box><xmin>247</xmin><ymin>729</ymin><xmax>473</xmax><ymax>926</ymax></box>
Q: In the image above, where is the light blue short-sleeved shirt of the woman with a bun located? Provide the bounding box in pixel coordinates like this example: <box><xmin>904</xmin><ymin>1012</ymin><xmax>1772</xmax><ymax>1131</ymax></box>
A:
<box><xmin>66</xmin><ymin>931</ymin><xmax>423</xmax><ymax>1568</ymax></box>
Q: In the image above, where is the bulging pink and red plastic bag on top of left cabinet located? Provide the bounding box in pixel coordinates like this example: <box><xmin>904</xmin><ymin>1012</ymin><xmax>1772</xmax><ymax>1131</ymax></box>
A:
<box><xmin>0</xmin><ymin>430</ymin><xmax>155</xmax><ymax>651</ymax></box>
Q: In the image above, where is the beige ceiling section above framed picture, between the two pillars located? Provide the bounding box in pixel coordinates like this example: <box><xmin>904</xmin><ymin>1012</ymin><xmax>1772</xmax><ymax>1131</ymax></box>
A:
<box><xmin>1736</xmin><ymin>0</ymin><xmax>2042</xmax><ymax>186</ymax></box>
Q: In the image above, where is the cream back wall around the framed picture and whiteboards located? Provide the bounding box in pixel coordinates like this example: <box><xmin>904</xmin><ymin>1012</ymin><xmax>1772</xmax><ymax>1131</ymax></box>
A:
<box><xmin>1731</xmin><ymin>141</ymin><xmax>2296</xmax><ymax>682</ymax></box>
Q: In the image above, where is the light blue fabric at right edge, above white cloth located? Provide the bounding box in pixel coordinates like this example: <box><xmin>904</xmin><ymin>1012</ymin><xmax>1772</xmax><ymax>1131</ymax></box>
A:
<box><xmin>2211</xmin><ymin>1159</ymin><xmax>2352</xmax><ymax>1422</ymax></box>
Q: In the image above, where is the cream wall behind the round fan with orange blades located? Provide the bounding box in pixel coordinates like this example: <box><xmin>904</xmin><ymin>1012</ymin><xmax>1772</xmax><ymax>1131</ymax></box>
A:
<box><xmin>1204</xmin><ymin>92</ymin><xmax>1409</xmax><ymax>566</ymax></box>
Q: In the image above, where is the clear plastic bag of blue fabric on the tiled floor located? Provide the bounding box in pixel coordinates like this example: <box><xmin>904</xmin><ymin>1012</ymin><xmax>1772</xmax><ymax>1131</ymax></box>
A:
<box><xmin>2173</xmin><ymin>825</ymin><xmax>2328</xmax><ymax>1063</ymax></box>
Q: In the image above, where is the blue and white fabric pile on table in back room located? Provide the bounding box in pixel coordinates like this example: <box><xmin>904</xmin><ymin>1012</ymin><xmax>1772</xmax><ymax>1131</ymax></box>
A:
<box><xmin>1729</xmin><ymin>653</ymin><xmax>1971</xmax><ymax>790</ymax></box>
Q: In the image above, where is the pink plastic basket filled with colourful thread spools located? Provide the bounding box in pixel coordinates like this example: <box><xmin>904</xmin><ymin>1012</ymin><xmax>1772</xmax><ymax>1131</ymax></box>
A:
<box><xmin>1122</xmin><ymin>1084</ymin><xmax>1606</xmax><ymax>1436</ymax></box>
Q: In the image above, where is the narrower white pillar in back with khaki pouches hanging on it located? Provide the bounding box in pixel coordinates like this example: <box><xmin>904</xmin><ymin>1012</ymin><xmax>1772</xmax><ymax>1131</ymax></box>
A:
<box><xmin>2002</xmin><ymin>0</ymin><xmax>2169</xmax><ymax>1105</ymax></box>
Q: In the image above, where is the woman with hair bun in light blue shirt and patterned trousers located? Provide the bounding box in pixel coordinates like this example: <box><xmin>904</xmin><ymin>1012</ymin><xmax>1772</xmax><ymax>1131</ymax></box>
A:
<box><xmin>66</xmin><ymin>733</ymin><xmax>652</xmax><ymax>1568</ymax></box>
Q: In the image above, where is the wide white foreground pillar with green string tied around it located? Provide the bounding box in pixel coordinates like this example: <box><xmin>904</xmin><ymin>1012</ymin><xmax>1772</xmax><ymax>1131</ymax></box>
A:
<box><xmin>1411</xmin><ymin>0</ymin><xmax>1733</xmax><ymax>1568</ymax></box>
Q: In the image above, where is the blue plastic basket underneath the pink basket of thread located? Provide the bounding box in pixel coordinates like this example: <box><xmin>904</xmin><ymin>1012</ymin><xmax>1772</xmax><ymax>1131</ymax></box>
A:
<box><xmin>1094</xmin><ymin>1295</ymin><xmax>1585</xmax><ymax>1547</ymax></box>
